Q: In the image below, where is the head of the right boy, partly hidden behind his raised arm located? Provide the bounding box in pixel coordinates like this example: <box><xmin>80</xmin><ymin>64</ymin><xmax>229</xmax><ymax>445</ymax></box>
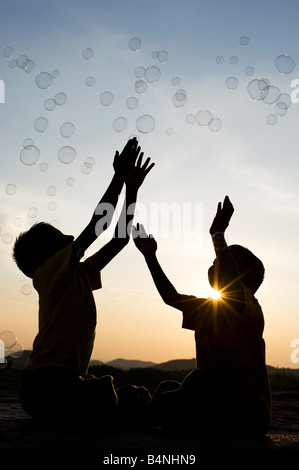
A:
<box><xmin>208</xmin><ymin>245</ymin><xmax>265</xmax><ymax>294</ymax></box>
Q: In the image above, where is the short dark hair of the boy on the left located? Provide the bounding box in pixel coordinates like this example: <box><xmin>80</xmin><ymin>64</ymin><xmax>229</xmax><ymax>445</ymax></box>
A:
<box><xmin>12</xmin><ymin>222</ymin><xmax>54</xmax><ymax>278</ymax></box>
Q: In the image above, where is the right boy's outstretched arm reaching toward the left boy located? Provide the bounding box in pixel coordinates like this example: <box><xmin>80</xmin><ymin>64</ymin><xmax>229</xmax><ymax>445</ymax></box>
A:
<box><xmin>133</xmin><ymin>224</ymin><xmax>189</xmax><ymax>310</ymax></box>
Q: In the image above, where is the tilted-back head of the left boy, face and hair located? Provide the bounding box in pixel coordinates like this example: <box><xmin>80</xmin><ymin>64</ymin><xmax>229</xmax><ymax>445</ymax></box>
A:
<box><xmin>13</xmin><ymin>222</ymin><xmax>74</xmax><ymax>278</ymax></box>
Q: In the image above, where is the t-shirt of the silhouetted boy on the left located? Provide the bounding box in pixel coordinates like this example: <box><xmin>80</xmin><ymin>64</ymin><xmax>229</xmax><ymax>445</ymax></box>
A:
<box><xmin>26</xmin><ymin>243</ymin><xmax>102</xmax><ymax>374</ymax></box>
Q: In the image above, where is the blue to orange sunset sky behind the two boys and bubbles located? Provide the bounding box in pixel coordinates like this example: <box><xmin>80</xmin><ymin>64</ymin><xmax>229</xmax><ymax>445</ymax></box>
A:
<box><xmin>0</xmin><ymin>0</ymin><xmax>299</xmax><ymax>368</ymax></box>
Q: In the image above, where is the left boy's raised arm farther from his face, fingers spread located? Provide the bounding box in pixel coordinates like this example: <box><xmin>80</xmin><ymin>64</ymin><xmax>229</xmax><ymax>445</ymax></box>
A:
<box><xmin>99</xmin><ymin>153</ymin><xmax>155</xmax><ymax>270</ymax></box>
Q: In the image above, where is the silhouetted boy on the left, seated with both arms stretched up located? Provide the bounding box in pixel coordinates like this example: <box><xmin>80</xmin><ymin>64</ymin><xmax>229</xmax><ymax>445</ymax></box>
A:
<box><xmin>13</xmin><ymin>138</ymin><xmax>153</xmax><ymax>426</ymax></box>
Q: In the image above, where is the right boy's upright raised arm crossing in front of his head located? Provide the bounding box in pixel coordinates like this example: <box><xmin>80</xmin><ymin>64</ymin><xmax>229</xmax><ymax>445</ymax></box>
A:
<box><xmin>210</xmin><ymin>196</ymin><xmax>244</xmax><ymax>302</ymax></box>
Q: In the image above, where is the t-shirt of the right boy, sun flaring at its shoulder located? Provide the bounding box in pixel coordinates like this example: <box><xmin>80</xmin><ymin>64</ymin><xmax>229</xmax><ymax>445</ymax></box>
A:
<box><xmin>181</xmin><ymin>288</ymin><xmax>271</xmax><ymax>417</ymax></box>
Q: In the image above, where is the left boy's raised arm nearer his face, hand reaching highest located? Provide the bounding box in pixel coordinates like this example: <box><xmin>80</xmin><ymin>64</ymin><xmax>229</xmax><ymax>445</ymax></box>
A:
<box><xmin>71</xmin><ymin>138</ymin><xmax>140</xmax><ymax>266</ymax></box>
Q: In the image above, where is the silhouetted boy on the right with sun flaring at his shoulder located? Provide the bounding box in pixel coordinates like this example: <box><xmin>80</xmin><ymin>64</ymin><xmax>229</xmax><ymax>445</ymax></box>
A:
<box><xmin>133</xmin><ymin>197</ymin><xmax>271</xmax><ymax>434</ymax></box>
